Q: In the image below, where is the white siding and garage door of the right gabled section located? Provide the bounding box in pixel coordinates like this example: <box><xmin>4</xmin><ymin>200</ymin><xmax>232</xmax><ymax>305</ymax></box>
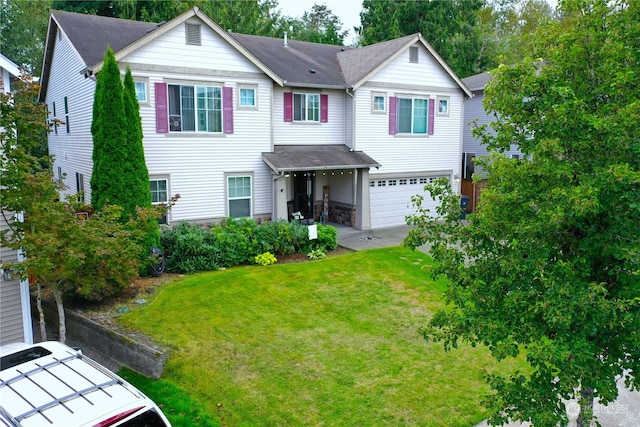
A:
<box><xmin>355</xmin><ymin>43</ymin><xmax>464</xmax><ymax>228</ymax></box>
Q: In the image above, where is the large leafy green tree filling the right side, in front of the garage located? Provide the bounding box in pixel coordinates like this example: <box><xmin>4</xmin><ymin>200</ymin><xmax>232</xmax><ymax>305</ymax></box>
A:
<box><xmin>407</xmin><ymin>0</ymin><xmax>640</xmax><ymax>426</ymax></box>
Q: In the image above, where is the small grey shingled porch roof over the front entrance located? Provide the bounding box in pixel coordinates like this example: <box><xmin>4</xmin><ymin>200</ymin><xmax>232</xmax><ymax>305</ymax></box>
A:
<box><xmin>262</xmin><ymin>145</ymin><xmax>381</xmax><ymax>173</ymax></box>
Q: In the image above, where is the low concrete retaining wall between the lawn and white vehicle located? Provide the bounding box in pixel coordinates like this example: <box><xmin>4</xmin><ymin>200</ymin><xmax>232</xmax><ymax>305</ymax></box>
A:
<box><xmin>31</xmin><ymin>301</ymin><xmax>168</xmax><ymax>379</ymax></box>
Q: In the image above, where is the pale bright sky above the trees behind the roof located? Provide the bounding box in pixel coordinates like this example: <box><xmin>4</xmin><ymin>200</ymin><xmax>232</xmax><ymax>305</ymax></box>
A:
<box><xmin>278</xmin><ymin>0</ymin><xmax>558</xmax><ymax>46</ymax></box>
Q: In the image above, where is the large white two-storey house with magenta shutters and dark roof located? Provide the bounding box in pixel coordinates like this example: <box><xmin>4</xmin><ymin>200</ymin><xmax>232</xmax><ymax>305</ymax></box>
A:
<box><xmin>40</xmin><ymin>8</ymin><xmax>471</xmax><ymax>230</ymax></box>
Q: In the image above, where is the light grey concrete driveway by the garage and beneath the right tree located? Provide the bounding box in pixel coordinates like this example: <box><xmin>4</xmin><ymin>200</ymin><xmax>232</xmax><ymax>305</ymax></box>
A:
<box><xmin>330</xmin><ymin>224</ymin><xmax>640</xmax><ymax>427</ymax></box>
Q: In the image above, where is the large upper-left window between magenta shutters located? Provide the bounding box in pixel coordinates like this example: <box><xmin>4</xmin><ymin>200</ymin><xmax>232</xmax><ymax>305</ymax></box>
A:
<box><xmin>167</xmin><ymin>84</ymin><xmax>222</xmax><ymax>133</ymax></box>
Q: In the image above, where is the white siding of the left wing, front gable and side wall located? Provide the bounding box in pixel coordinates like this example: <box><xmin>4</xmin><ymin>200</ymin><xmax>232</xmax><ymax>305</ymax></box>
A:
<box><xmin>47</xmin><ymin>16</ymin><xmax>272</xmax><ymax>223</ymax></box>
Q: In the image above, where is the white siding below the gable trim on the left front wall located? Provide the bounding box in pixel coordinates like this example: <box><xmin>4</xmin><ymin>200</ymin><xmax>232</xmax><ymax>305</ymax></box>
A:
<box><xmin>140</xmin><ymin>70</ymin><xmax>273</xmax><ymax>222</ymax></box>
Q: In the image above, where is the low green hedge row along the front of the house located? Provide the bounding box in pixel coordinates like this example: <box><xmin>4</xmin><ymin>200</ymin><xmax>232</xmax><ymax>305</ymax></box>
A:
<box><xmin>160</xmin><ymin>219</ymin><xmax>338</xmax><ymax>273</ymax></box>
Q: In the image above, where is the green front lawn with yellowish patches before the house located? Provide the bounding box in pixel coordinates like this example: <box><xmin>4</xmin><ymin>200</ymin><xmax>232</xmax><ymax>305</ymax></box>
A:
<box><xmin>121</xmin><ymin>247</ymin><xmax>524</xmax><ymax>427</ymax></box>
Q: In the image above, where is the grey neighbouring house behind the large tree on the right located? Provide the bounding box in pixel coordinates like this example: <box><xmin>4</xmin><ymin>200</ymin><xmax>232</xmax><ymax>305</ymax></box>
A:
<box><xmin>460</xmin><ymin>73</ymin><xmax>522</xmax><ymax>212</ymax></box>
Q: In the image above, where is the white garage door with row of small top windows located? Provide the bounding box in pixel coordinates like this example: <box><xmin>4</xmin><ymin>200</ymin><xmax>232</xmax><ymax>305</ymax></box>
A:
<box><xmin>369</xmin><ymin>176</ymin><xmax>440</xmax><ymax>229</ymax></box>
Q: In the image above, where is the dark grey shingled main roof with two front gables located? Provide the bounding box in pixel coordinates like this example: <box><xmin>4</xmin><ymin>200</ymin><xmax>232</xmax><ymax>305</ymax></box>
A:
<box><xmin>40</xmin><ymin>7</ymin><xmax>473</xmax><ymax>100</ymax></box>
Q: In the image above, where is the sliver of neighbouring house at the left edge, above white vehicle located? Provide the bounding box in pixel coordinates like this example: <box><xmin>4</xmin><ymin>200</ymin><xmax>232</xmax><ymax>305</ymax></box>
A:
<box><xmin>0</xmin><ymin>53</ymin><xmax>33</xmax><ymax>345</ymax></box>
